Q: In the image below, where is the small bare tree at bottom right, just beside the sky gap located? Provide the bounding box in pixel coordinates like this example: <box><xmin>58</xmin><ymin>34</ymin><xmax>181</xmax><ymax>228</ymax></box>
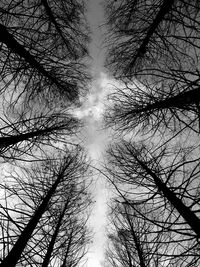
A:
<box><xmin>106</xmin><ymin>199</ymin><xmax>173</xmax><ymax>267</ymax></box>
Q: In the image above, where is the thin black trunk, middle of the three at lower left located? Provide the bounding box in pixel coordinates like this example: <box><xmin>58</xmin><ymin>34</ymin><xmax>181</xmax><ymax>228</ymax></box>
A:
<box><xmin>42</xmin><ymin>201</ymin><xmax>68</xmax><ymax>267</ymax></box>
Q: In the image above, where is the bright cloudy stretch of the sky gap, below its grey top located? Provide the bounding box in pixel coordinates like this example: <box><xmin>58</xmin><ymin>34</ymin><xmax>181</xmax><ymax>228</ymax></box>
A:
<box><xmin>73</xmin><ymin>73</ymin><xmax>114</xmax><ymax>267</ymax></box>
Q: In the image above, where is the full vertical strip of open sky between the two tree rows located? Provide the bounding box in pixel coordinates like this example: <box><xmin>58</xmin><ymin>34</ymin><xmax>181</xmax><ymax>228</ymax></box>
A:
<box><xmin>75</xmin><ymin>0</ymin><xmax>113</xmax><ymax>267</ymax></box>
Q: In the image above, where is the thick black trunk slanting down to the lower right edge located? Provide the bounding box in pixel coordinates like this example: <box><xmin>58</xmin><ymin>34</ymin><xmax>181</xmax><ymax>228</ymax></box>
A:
<box><xmin>134</xmin><ymin>156</ymin><xmax>200</xmax><ymax>238</ymax></box>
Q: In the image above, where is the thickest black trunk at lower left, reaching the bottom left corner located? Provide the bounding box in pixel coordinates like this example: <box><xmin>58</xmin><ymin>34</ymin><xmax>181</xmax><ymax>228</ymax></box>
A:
<box><xmin>0</xmin><ymin>172</ymin><xmax>63</xmax><ymax>267</ymax></box>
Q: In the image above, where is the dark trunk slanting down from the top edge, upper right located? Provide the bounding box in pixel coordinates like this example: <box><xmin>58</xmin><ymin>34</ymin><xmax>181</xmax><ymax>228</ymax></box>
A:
<box><xmin>130</xmin><ymin>0</ymin><xmax>174</xmax><ymax>68</ymax></box>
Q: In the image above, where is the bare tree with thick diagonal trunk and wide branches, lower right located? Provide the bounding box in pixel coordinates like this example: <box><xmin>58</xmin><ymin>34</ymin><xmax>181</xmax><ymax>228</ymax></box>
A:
<box><xmin>104</xmin><ymin>142</ymin><xmax>200</xmax><ymax>266</ymax></box>
